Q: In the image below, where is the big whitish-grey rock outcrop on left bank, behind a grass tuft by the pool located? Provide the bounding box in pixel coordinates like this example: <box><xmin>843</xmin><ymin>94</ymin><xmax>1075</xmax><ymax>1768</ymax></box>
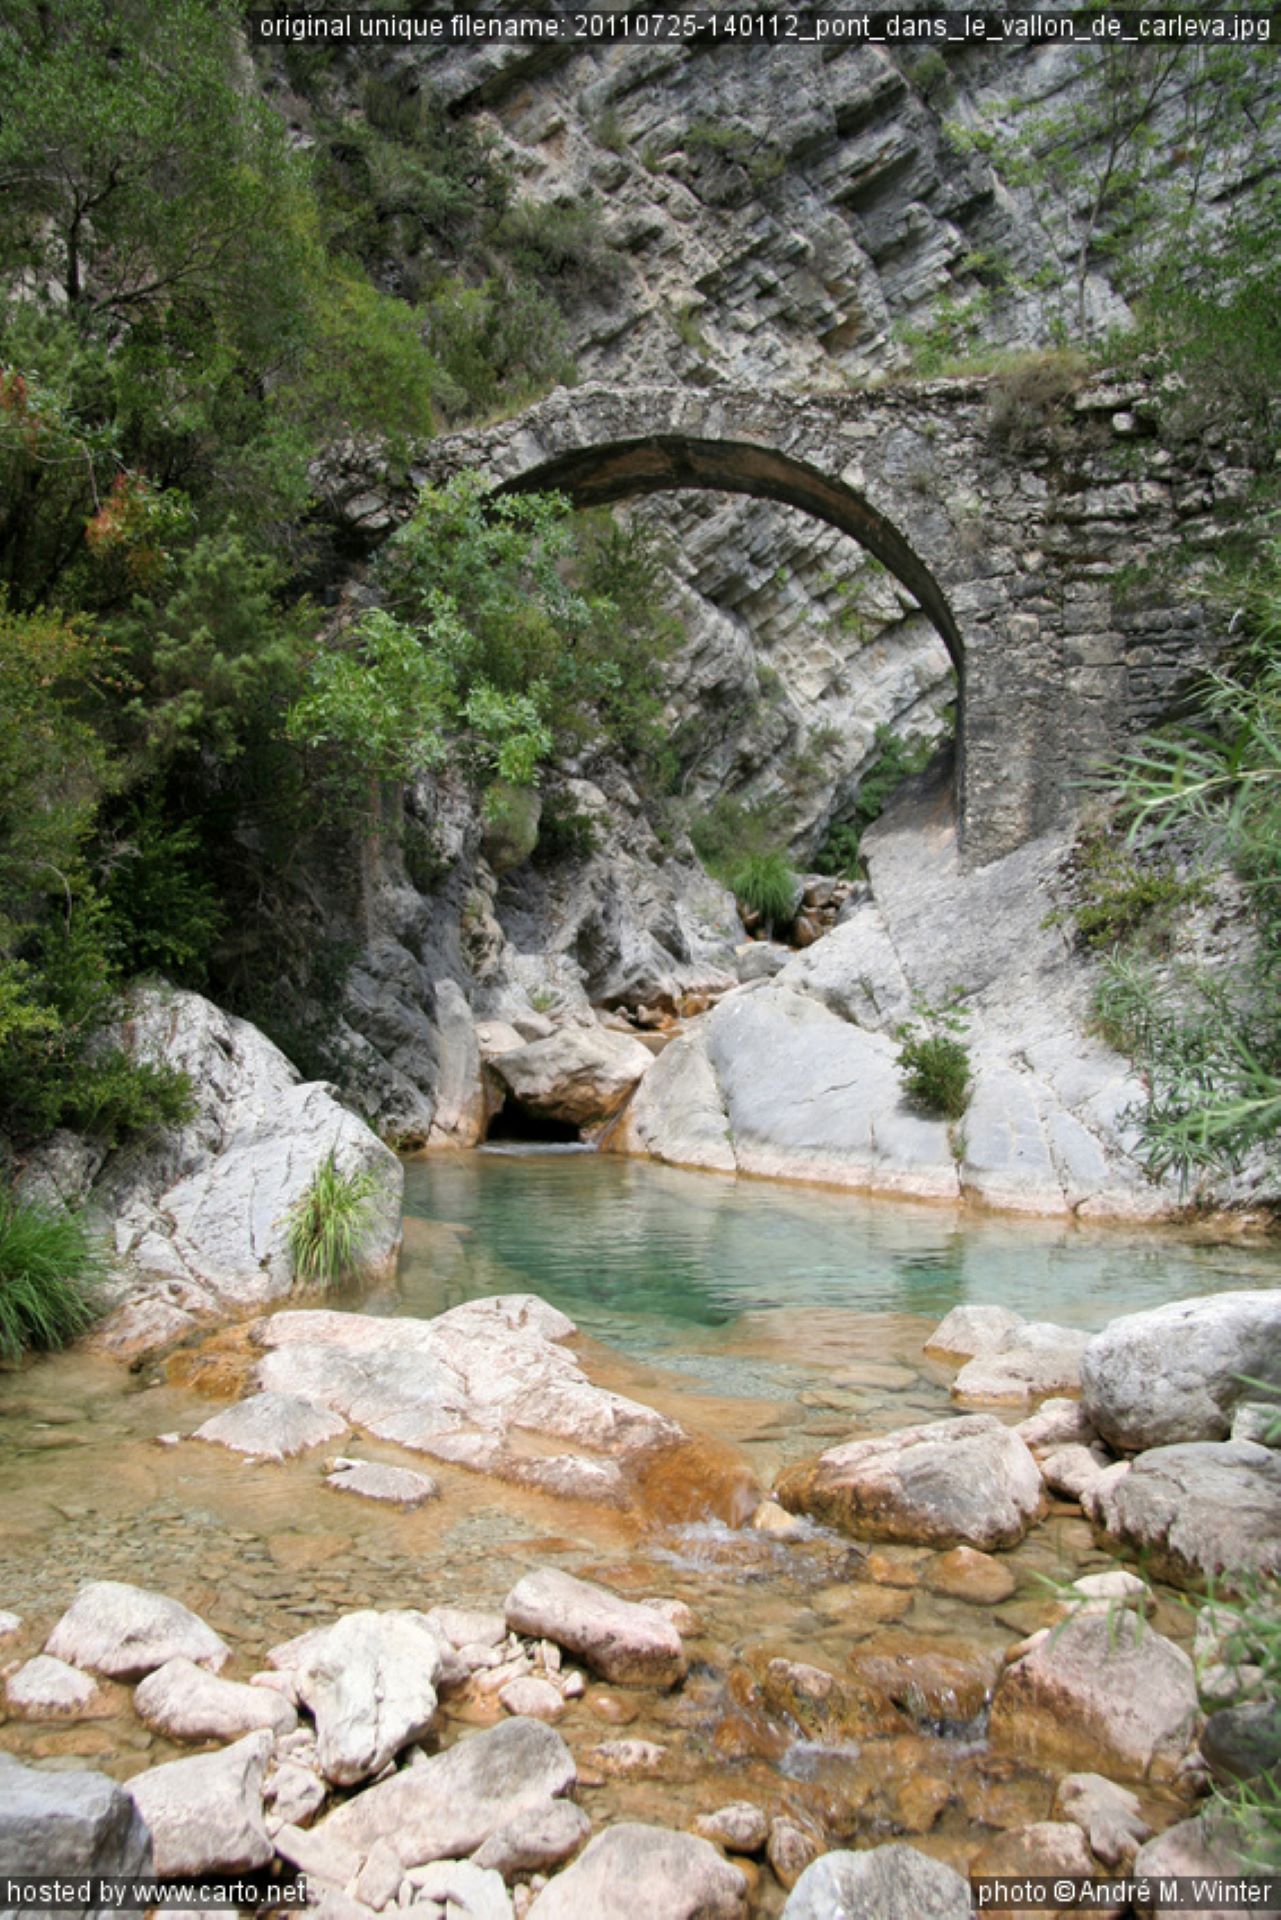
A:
<box><xmin>92</xmin><ymin>987</ymin><xmax>403</xmax><ymax>1350</ymax></box>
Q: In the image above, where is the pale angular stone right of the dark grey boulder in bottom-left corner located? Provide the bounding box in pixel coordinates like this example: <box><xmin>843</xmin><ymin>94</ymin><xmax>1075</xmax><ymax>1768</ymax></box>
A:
<box><xmin>129</xmin><ymin>1732</ymin><xmax>275</xmax><ymax>1874</ymax></box>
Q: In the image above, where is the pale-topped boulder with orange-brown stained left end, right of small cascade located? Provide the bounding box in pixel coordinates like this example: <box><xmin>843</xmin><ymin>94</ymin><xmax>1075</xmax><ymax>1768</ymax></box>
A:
<box><xmin>776</xmin><ymin>1413</ymin><xmax>1045</xmax><ymax>1549</ymax></box>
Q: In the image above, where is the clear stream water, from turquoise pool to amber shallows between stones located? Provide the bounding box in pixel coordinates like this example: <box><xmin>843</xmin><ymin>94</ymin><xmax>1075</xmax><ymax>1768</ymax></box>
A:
<box><xmin>0</xmin><ymin>1150</ymin><xmax>1281</xmax><ymax>1914</ymax></box>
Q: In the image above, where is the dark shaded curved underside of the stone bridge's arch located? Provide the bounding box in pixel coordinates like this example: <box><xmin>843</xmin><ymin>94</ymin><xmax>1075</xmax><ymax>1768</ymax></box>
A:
<box><xmin>495</xmin><ymin>434</ymin><xmax>964</xmax><ymax>680</ymax></box>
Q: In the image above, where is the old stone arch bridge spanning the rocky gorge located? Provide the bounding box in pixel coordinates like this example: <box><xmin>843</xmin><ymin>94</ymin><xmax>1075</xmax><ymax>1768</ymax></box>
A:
<box><xmin>340</xmin><ymin>376</ymin><xmax>1248</xmax><ymax>866</ymax></box>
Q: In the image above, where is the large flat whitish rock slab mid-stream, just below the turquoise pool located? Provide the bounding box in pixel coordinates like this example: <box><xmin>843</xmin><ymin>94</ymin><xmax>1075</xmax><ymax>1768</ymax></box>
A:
<box><xmin>242</xmin><ymin>1294</ymin><xmax>684</xmax><ymax>1503</ymax></box>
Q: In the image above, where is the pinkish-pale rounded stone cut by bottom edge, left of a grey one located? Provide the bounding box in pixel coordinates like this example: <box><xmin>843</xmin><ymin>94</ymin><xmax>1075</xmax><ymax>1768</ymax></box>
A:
<box><xmin>528</xmin><ymin>1820</ymin><xmax>747</xmax><ymax>1920</ymax></box>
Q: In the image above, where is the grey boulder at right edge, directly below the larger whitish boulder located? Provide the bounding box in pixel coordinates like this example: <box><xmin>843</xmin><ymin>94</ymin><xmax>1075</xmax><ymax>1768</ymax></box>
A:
<box><xmin>1085</xmin><ymin>1440</ymin><xmax>1281</xmax><ymax>1586</ymax></box>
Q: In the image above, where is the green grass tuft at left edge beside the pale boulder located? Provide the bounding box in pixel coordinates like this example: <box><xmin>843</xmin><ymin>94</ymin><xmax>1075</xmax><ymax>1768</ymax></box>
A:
<box><xmin>0</xmin><ymin>1194</ymin><xmax>108</xmax><ymax>1359</ymax></box>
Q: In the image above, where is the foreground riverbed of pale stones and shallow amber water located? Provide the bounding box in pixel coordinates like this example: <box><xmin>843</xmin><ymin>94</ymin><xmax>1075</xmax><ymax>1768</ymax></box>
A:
<box><xmin>0</xmin><ymin>1267</ymin><xmax>1281</xmax><ymax>1920</ymax></box>
